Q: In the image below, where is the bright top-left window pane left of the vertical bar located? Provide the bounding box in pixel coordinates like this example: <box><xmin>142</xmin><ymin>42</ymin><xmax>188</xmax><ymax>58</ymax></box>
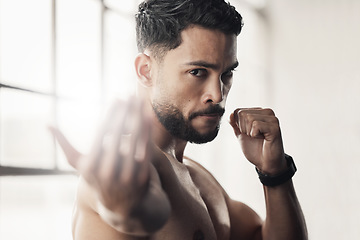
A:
<box><xmin>0</xmin><ymin>0</ymin><xmax>51</xmax><ymax>92</ymax></box>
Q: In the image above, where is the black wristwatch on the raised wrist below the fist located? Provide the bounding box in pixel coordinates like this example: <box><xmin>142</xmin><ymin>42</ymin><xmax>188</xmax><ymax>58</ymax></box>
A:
<box><xmin>255</xmin><ymin>154</ymin><xmax>297</xmax><ymax>187</ymax></box>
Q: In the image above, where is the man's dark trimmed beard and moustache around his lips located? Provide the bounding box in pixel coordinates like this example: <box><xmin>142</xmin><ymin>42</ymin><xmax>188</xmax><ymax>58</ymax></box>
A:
<box><xmin>152</xmin><ymin>103</ymin><xmax>225</xmax><ymax>144</ymax></box>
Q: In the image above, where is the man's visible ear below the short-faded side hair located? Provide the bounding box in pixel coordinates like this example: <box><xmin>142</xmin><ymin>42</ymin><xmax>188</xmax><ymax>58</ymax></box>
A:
<box><xmin>135</xmin><ymin>53</ymin><xmax>152</xmax><ymax>87</ymax></box>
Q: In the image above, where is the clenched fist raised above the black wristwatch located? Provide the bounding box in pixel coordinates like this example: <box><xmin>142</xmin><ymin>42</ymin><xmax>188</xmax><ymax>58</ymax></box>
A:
<box><xmin>230</xmin><ymin>108</ymin><xmax>287</xmax><ymax>174</ymax></box>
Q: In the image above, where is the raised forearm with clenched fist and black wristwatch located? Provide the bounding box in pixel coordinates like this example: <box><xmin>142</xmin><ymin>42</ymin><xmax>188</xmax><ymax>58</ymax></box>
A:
<box><xmin>230</xmin><ymin>108</ymin><xmax>307</xmax><ymax>240</ymax></box>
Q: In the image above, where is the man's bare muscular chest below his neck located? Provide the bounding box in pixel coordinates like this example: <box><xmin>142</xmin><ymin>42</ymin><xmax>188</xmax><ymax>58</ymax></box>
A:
<box><xmin>152</xmin><ymin>158</ymin><xmax>230</xmax><ymax>240</ymax></box>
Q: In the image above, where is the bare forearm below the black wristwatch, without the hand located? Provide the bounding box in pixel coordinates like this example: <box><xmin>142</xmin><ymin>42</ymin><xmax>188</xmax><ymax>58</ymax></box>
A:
<box><xmin>262</xmin><ymin>180</ymin><xmax>307</xmax><ymax>240</ymax></box>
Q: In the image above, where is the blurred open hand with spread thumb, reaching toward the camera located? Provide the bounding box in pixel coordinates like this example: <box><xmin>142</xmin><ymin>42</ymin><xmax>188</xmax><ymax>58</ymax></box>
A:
<box><xmin>51</xmin><ymin>98</ymin><xmax>158</xmax><ymax>218</ymax></box>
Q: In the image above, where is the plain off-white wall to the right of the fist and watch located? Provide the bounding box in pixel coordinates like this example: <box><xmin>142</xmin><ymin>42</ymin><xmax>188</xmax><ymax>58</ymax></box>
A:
<box><xmin>268</xmin><ymin>0</ymin><xmax>360</xmax><ymax>240</ymax></box>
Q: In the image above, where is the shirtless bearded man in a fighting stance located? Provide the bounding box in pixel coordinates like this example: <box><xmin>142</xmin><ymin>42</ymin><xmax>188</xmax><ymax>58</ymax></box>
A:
<box><xmin>53</xmin><ymin>0</ymin><xmax>307</xmax><ymax>240</ymax></box>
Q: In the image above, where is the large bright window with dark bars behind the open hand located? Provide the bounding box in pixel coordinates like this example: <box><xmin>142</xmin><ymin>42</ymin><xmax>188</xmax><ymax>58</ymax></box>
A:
<box><xmin>0</xmin><ymin>0</ymin><xmax>137</xmax><ymax>239</ymax></box>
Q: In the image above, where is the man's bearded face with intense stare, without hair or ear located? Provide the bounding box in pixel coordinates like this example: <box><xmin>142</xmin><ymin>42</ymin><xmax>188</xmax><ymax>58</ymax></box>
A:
<box><xmin>152</xmin><ymin>26</ymin><xmax>238</xmax><ymax>143</ymax></box>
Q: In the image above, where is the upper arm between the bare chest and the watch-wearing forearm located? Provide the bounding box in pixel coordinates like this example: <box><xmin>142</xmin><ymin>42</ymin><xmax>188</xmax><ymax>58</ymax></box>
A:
<box><xmin>227</xmin><ymin>199</ymin><xmax>263</xmax><ymax>240</ymax></box>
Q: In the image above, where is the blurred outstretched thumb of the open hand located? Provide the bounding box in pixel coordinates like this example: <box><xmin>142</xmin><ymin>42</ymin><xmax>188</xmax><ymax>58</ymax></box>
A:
<box><xmin>48</xmin><ymin>126</ymin><xmax>82</xmax><ymax>169</ymax></box>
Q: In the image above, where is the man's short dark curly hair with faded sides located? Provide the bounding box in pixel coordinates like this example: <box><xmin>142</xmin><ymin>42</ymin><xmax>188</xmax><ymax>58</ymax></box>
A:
<box><xmin>135</xmin><ymin>0</ymin><xmax>243</xmax><ymax>58</ymax></box>
